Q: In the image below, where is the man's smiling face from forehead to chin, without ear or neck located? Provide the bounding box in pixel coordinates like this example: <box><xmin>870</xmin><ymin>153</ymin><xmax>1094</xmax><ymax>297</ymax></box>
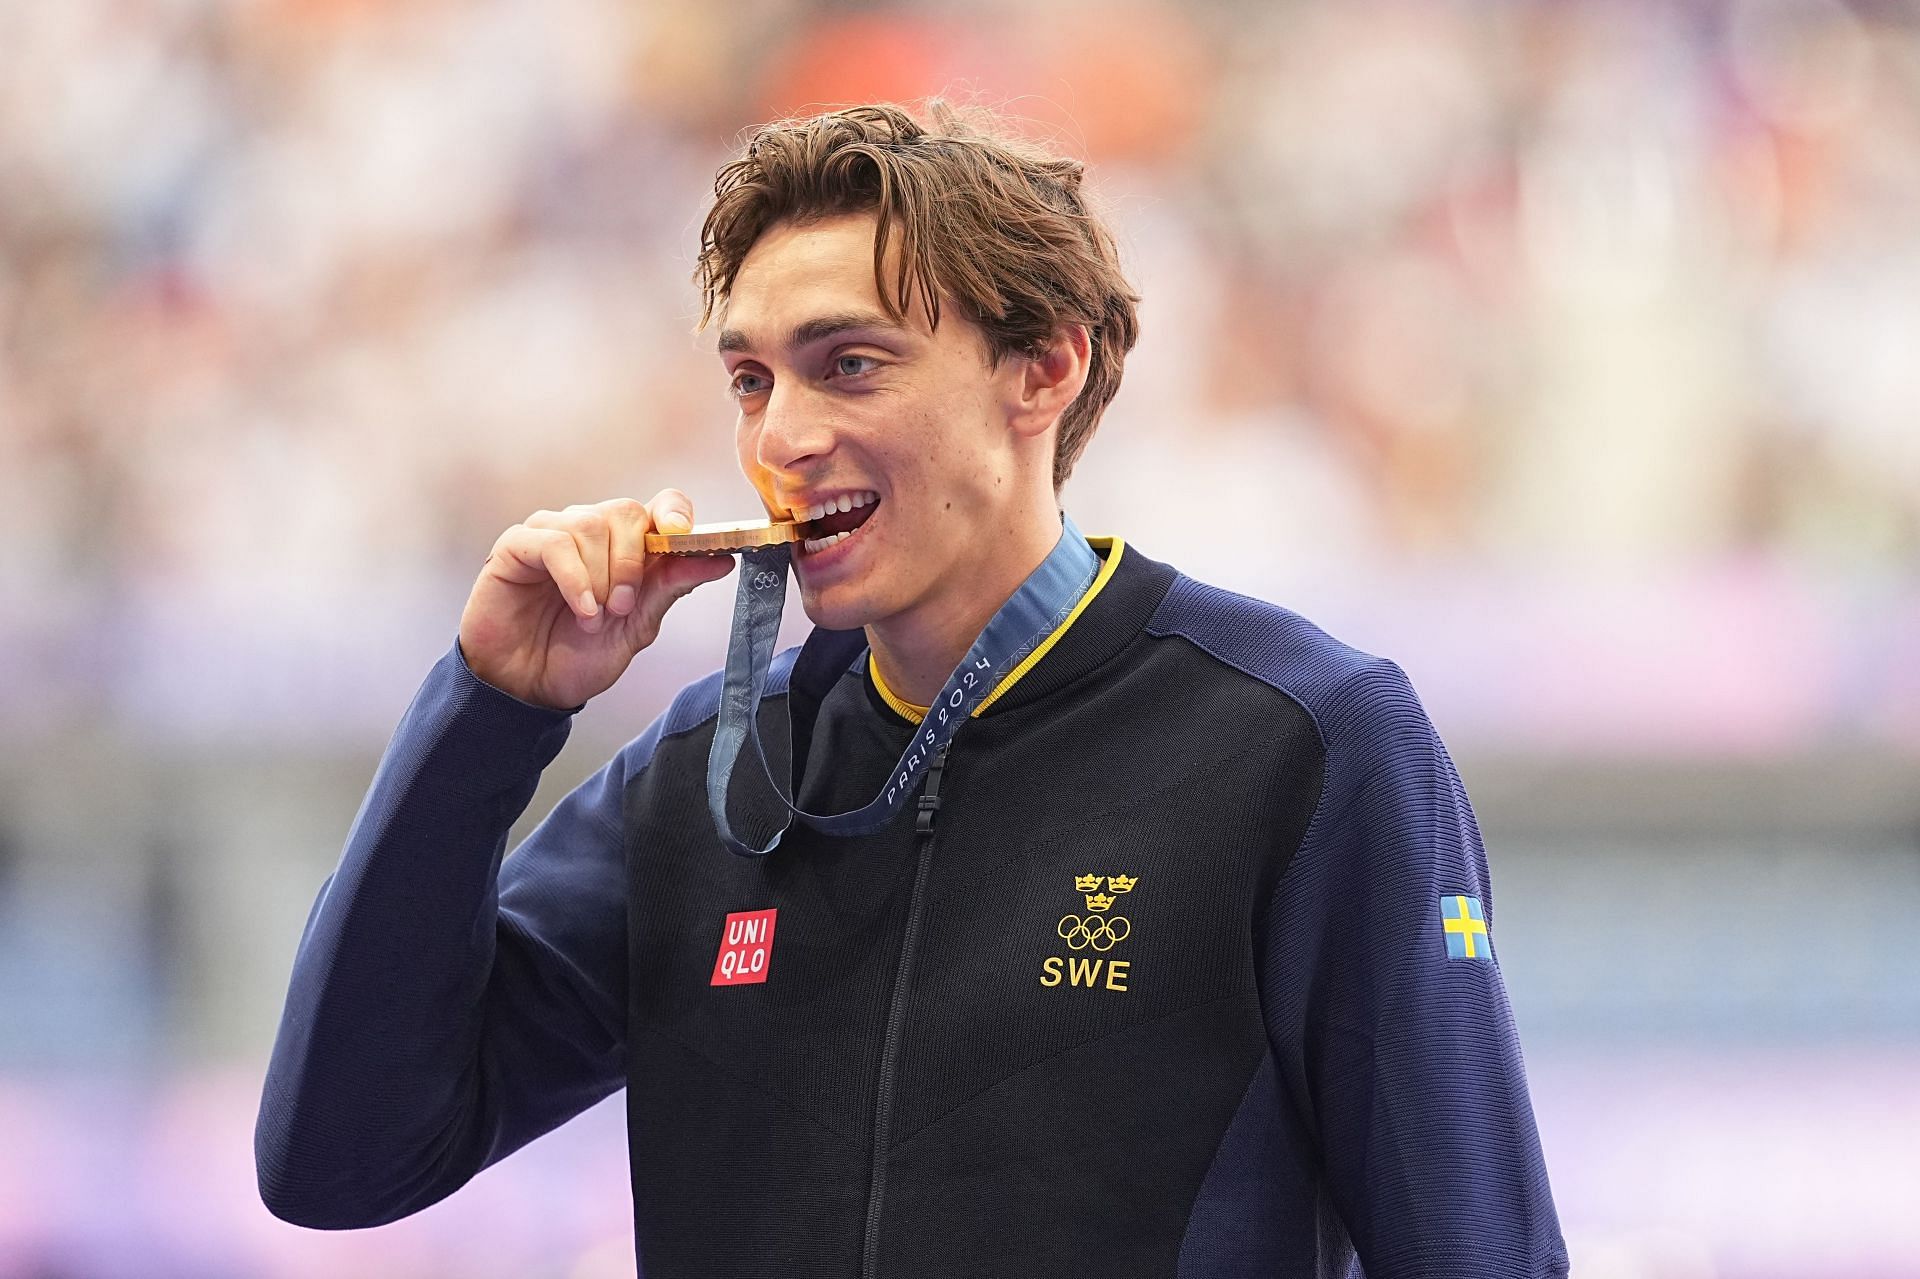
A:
<box><xmin>720</xmin><ymin>213</ymin><xmax>1020</xmax><ymax>630</ymax></box>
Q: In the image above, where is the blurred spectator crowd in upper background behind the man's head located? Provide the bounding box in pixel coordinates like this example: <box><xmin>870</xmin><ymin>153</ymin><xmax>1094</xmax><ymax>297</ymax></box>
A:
<box><xmin>0</xmin><ymin>0</ymin><xmax>1920</xmax><ymax>737</ymax></box>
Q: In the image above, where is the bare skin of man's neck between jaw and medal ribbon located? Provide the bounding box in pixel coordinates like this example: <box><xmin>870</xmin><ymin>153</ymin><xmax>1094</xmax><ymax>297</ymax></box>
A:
<box><xmin>866</xmin><ymin>507</ymin><xmax>1060</xmax><ymax>707</ymax></box>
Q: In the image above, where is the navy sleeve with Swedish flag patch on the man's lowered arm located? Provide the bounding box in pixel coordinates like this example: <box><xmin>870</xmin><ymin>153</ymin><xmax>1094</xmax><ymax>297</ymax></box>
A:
<box><xmin>1261</xmin><ymin>661</ymin><xmax>1567</xmax><ymax>1279</ymax></box>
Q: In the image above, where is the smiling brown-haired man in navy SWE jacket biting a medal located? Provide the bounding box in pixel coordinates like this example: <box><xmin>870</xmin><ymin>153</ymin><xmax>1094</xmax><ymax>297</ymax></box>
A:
<box><xmin>257</xmin><ymin>106</ymin><xmax>1567</xmax><ymax>1279</ymax></box>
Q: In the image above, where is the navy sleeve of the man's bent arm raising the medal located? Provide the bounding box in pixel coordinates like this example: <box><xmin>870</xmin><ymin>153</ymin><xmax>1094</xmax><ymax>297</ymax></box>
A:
<box><xmin>253</xmin><ymin>643</ymin><xmax>629</xmax><ymax>1229</ymax></box>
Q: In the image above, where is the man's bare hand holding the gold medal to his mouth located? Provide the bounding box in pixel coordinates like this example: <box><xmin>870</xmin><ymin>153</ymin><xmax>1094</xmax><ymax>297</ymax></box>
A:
<box><xmin>461</xmin><ymin>488</ymin><xmax>733</xmax><ymax>711</ymax></box>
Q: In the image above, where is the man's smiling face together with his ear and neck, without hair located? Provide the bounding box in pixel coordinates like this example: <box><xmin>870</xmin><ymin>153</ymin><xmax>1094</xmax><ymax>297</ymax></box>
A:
<box><xmin>718</xmin><ymin>213</ymin><xmax>1082</xmax><ymax>701</ymax></box>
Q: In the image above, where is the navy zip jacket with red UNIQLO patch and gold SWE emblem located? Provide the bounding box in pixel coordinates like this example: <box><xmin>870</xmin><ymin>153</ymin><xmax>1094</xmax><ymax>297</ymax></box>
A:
<box><xmin>255</xmin><ymin>540</ymin><xmax>1567</xmax><ymax>1279</ymax></box>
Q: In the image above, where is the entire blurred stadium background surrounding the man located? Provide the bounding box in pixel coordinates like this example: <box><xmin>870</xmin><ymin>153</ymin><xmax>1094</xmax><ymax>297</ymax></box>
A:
<box><xmin>0</xmin><ymin>0</ymin><xmax>1920</xmax><ymax>1279</ymax></box>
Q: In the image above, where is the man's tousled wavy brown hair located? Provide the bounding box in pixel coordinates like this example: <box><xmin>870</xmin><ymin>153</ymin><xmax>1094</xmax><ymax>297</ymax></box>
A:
<box><xmin>693</xmin><ymin>98</ymin><xmax>1140</xmax><ymax>492</ymax></box>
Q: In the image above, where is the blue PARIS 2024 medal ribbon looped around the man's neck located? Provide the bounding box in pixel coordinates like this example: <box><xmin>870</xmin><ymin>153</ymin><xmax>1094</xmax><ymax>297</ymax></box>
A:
<box><xmin>707</xmin><ymin>515</ymin><xmax>1100</xmax><ymax>857</ymax></box>
